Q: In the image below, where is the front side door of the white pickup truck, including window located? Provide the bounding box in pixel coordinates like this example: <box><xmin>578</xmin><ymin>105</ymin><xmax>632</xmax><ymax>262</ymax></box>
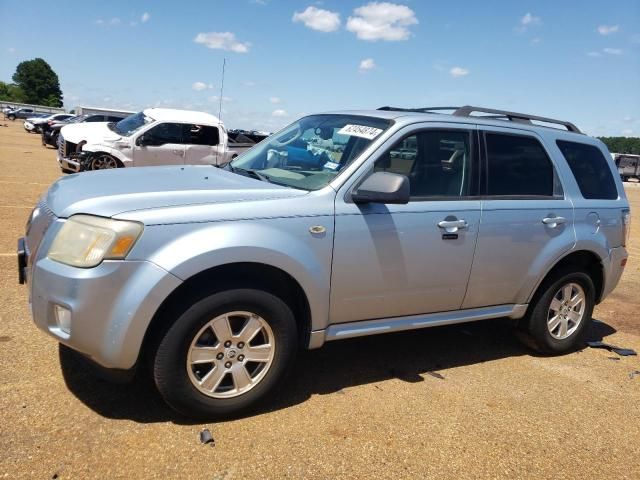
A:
<box><xmin>133</xmin><ymin>122</ymin><xmax>185</xmax><ymax>167</ymax></box>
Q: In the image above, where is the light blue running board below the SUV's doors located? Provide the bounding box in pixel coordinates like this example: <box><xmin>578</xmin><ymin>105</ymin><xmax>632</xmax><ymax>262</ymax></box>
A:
<box><xmin>309</xmin><ymin>304</ymin><xmax>528</xmax><ymax>348</ymax></box>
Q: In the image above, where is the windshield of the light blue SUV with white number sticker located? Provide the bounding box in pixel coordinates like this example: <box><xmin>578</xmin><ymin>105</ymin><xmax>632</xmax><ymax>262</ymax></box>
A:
<box><xmin>227</xmin><ymin>114</ymin><xmax>391</xmax><ymax>190</ymax></box>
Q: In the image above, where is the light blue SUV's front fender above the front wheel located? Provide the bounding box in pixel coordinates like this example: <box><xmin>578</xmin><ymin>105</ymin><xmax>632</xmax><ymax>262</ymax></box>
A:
<box><xmin>130</xmin><ymin>216</ymin><xmax>333</xmax><ymax>330</ymax></box>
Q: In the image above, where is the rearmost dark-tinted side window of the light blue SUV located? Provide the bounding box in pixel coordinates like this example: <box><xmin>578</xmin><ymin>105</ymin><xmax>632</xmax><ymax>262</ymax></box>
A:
<box><xmin>556</xmin><ymin>140</ymin><xmax>618</xmax><ymax>200</ymax></box>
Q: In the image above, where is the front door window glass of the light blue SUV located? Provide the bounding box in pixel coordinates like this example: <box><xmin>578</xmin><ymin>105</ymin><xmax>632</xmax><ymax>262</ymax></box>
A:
<box><xmin>374</xmin><ymin>130</ymin><xmax>474</xmax><ymax>198</ymax></box>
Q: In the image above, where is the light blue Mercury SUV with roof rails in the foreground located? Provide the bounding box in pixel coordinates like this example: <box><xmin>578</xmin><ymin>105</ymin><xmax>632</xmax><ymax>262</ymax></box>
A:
<box><xmin>19</xmin><ymin>107</ymin><xmax>630</xmax><ymax>417</ymax></box>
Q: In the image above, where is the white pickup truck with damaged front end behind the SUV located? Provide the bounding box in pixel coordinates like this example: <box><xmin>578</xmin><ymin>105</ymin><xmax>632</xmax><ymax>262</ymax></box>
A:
<box><xmin>58</xmin><ymin>108</ymin><xmax>253</xmax><ymax>173</ymax></box>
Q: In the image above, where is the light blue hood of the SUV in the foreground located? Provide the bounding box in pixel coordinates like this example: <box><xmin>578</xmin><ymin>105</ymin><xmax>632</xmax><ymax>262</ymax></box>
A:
<box><xmin>46</xmin><ymin>165</ymin><xmax>307</xmax><ymax>221</ymax></box>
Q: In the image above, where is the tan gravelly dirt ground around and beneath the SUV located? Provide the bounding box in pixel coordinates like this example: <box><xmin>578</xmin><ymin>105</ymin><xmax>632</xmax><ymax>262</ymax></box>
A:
<box><xmin>0</xmin><ymin>117</ymin><xmax>640</xmax><ymax>480</ymax></box>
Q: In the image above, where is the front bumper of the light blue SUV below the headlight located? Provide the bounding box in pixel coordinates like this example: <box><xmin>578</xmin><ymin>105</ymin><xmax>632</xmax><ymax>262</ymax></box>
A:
<box><xmin>29</xmin><ymin>257</ymin><xmax>181</xmax><ymax>370</ymax></box>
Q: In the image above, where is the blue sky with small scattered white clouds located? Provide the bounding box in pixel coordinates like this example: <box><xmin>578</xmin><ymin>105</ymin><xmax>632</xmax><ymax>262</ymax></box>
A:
<box><xmin>0</xmin><ymin>0</ymin><xmax>640</xmax><ymax>136</ymax></box>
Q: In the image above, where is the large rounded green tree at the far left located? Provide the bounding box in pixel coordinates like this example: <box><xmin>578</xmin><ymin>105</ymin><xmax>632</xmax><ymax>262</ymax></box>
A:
<box><xmin>13</xmin><ymin>58</ymin><xmax>62</xmax><ymax>107</ymax></box>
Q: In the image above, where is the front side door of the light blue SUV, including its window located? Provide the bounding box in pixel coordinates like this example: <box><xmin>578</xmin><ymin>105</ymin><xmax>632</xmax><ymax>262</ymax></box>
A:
<box><xmin>330</xmin><ymin>124</ymin><xmax>480</xmax><ymax>323</ymax></box>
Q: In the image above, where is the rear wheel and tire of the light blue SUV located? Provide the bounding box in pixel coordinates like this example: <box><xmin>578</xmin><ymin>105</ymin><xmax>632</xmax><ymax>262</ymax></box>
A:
<box><xmin>520</xmin><ymin>269</ymin><xmax>595</xmax><ymax>354</ymax></box>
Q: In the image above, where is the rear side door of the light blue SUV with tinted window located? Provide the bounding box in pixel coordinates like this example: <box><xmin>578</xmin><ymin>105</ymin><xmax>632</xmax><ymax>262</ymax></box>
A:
<box><xmin>463</xmin><ymin>127</ymin><xmax>575</xmax><ymax>308</ymax></box>
